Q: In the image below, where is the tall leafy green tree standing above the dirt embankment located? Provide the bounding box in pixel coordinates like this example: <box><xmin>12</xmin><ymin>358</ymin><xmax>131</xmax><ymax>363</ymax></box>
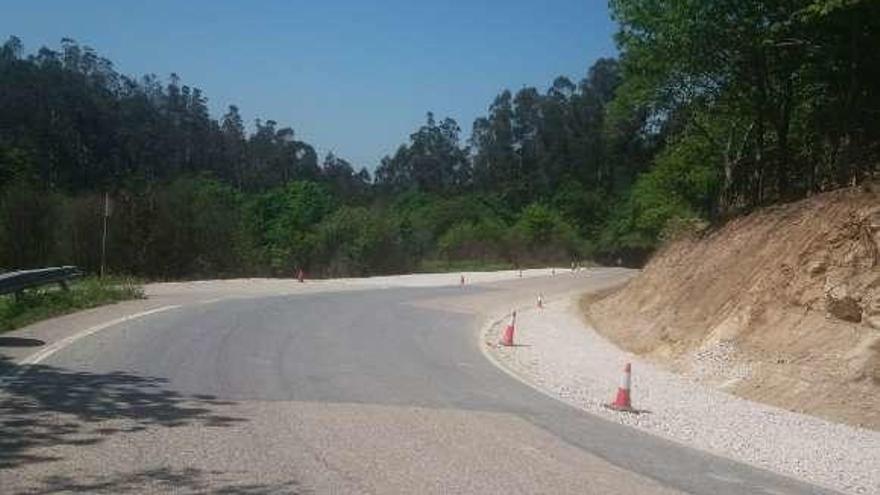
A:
<box><xmin>611</xmin><ymin>0</ymin><xmax>880</xmax><ymax>210</ymax></box>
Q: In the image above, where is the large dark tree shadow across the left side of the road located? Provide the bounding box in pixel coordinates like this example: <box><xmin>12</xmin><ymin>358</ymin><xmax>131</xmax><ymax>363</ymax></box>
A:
<box><xmin>0</xmin><ymin>356</ymin><xmax>245</xmax><ymax>469</ymax></box>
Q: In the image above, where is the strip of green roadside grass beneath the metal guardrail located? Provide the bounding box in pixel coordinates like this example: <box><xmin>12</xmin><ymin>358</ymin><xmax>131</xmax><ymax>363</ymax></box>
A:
<box><xmin>0</xmin><ymin>277</ymin><xmax>145</xmax><ymax>333</ymax></box>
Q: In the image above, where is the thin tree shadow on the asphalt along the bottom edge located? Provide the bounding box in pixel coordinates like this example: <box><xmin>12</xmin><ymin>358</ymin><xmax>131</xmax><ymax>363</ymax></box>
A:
<box><xmin>22</xmin><ymin>468</ymin><xmax>307</xmax><ymax>495</ymax></box>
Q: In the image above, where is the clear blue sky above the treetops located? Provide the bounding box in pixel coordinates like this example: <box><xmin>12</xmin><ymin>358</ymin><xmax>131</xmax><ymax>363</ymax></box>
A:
<box><xmin>0</xmin><ymin>0</ymin><xmax>616</xmax><ymax>170</ymax></box>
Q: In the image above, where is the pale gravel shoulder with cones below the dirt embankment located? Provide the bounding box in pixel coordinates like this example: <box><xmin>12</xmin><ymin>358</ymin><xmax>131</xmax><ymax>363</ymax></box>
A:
<box><xmin>480</xmin><ymin>295</ymin><xmax>880</xmax><ymax>494</ymax></box>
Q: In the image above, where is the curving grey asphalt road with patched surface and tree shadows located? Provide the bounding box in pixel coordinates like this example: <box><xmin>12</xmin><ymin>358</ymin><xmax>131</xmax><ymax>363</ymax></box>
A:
<box><xmin>0</xmin><ymin>274</ymin><xmax>831</xmax><ymax>495</ymax></box>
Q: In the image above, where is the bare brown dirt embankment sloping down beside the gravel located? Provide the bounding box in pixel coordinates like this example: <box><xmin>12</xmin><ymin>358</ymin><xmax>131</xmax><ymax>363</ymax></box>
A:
<box><xmin>584</xmin><ymin>187</ymin><xmax>880</xmax><ymax>430</ymax></box>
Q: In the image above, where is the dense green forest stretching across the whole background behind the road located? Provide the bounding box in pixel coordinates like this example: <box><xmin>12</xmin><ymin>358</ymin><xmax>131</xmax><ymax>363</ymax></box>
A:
<box><xmin>0</xmin><ymin>0</ymin><xmax>880</xmax><ymax>279</ymax></box>
